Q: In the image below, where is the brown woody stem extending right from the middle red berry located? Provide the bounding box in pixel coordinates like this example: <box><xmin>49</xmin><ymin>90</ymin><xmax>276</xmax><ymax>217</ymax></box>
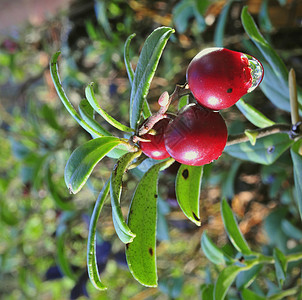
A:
<box><xmin>227</xmin><ymin>124</ymin><xmax>291</xmax><ymax>146</ymax></box>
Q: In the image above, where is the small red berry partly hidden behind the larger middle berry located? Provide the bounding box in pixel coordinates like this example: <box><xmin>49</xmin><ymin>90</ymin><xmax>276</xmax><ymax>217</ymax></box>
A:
<box><xmin>139</xmin><ymin>118</ymin><xmax>171</xmax><ymax>159</ymax></box>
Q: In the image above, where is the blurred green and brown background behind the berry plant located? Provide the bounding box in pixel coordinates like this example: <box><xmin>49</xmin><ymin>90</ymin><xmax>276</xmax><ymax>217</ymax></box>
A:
<box><xmin>0</xmin><ymin>0</ymin><xmax>302</xmax><ymax>300</ymax></box>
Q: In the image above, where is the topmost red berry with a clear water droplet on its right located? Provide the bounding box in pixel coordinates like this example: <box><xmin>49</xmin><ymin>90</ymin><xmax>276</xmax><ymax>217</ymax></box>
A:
<box><xmin>187</xmin><ymin>48</ymin><xmax>263</xmax><ymax>110</ymax></box>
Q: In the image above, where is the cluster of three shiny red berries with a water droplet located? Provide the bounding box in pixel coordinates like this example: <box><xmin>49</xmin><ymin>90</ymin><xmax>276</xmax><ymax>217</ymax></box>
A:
<box><xmin>139</xmin><ymin>48</ymin><xmax>263</xmax><ymax>166</ymax></box>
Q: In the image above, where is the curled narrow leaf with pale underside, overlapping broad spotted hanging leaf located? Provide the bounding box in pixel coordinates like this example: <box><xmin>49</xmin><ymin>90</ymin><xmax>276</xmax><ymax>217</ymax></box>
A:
<box><xmin>110</xmin><ymin>151</ymin><xmax>141</xmax><ymax>244</ymax></box>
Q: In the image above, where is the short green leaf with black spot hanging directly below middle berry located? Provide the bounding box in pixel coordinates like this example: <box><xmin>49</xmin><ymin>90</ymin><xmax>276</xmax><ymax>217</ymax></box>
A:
<box><xmin>175</xmin><ymin>164</ymin><xmax>203</xmax><ymax>226</ymax></box>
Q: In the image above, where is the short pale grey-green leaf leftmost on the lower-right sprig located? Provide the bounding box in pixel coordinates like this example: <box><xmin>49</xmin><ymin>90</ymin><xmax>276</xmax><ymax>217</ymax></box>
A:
<box><xmin>201</xmin><ymin>231</ymin><xmax>233</xmax><ymax>265</ymax></box>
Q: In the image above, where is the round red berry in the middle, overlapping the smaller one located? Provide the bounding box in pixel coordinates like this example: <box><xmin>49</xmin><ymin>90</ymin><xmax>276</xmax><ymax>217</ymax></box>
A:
<box><xmin>165</xmin><ymin>104</ymin><xmax>228</xmax><ymax>166</ymax></box>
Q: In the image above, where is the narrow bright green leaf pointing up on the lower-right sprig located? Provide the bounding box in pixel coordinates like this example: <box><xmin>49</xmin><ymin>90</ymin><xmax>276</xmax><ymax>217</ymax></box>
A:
<box><xmin>221</xmin><ymin>199</ymin><xmax>252</xmax><ymax>254</ymax></box>
